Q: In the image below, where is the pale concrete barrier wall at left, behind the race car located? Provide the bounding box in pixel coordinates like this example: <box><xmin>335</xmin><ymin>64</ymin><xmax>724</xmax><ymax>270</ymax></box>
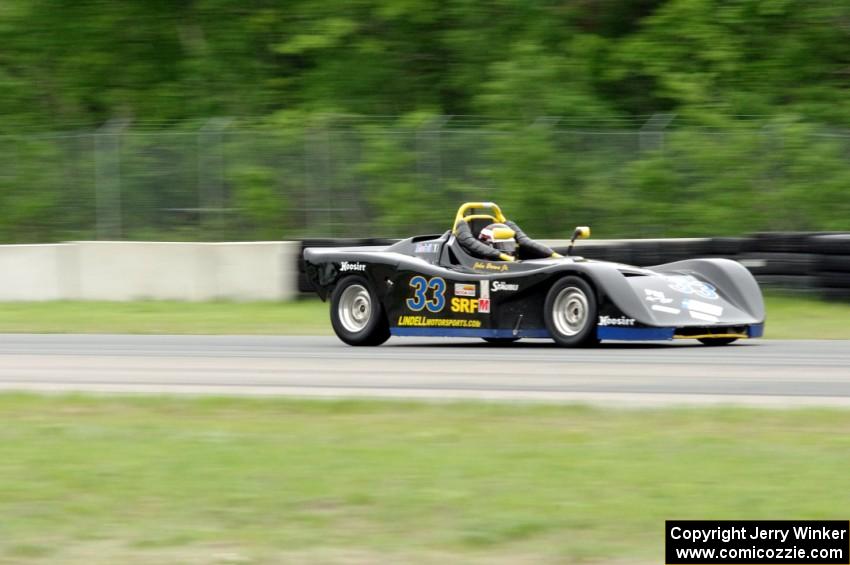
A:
<box><xmin>0</xmin><ymin>241</ymin><xmax>300</xmax><ymax>301</ymax></box>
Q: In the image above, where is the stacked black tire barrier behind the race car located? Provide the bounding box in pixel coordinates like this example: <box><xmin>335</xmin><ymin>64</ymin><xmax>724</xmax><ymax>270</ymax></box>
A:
<box><xmin>297</xmin><ymin>232</ymin><xmax>850</xmax><ymax>300</ymax></box>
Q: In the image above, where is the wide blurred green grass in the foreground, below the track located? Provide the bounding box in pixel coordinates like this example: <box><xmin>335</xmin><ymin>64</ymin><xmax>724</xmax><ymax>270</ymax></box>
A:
<box><xmin>0</xmin><ymin>395</ymin><xmax>850</xmax><ymax>564</ymax></box>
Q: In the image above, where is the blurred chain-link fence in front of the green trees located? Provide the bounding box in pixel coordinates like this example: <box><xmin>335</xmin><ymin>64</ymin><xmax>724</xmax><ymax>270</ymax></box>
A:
<box><xmin>0</xmin><ymin>116</ymin><xmax>850</xmax><ymax>243</ymax></box>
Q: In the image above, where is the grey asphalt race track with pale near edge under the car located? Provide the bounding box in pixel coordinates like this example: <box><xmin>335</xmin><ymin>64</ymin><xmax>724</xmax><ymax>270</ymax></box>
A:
<box><xmin>0</xmin><ymin>335</ymin><xmax>850</xmax><ymax>406</ymax></box>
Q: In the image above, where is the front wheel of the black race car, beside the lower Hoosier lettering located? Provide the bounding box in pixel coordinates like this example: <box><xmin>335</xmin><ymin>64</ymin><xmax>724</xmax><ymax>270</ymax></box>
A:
<box><xmin>543</xmin><ymin>277</ymin><xmax>599</xmax><ymax>347</ymax></box>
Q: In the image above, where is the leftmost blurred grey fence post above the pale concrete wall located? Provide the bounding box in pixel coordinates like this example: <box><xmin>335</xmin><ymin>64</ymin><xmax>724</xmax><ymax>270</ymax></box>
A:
<box><xmin>94</xmin><ymin>118</ymin><xmax>130</xmax><ymax>239</ymax></box>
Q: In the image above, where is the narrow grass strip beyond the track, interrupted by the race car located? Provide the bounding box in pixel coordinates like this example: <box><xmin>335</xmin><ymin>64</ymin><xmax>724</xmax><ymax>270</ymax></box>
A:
<box><xmin>0</xmin><ymin>294</ymin><xmax>850</xmax><ymax>339</ymax></box>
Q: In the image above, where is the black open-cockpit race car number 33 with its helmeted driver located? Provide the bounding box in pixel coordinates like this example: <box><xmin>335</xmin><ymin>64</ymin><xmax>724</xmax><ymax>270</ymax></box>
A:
<box><xmin>304</xmin><ymin>202</ymin><xmax>765</xmax><ymax>347</ymax></box>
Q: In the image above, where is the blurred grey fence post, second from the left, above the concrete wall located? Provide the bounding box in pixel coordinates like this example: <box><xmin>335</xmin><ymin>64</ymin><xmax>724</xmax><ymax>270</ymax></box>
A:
<box><xmin>197</xmin><ymin>117</ymin><xmax>233</xmax><ymax>235</ymax></box>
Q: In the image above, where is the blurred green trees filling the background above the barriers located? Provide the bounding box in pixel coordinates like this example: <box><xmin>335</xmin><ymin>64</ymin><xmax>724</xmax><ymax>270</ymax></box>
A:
<box><xmin>0</xmin><ymin>0</ymin><xmax>850</xmax><ymax>242</ymax></box>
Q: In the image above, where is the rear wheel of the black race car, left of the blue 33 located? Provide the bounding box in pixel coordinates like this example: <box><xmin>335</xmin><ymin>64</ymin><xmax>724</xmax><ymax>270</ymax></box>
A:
<box><xmin>331</xmin><ymin>276</ymin><xmax>390</xmax><ymax>345</ymax></box>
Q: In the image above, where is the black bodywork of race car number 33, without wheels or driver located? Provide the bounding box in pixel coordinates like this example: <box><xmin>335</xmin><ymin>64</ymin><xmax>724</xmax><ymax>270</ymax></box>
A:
<box><xmin>304</xmin><ymin>232</ymin><xmax>765</xmax><ymax>340</ymax></box>
